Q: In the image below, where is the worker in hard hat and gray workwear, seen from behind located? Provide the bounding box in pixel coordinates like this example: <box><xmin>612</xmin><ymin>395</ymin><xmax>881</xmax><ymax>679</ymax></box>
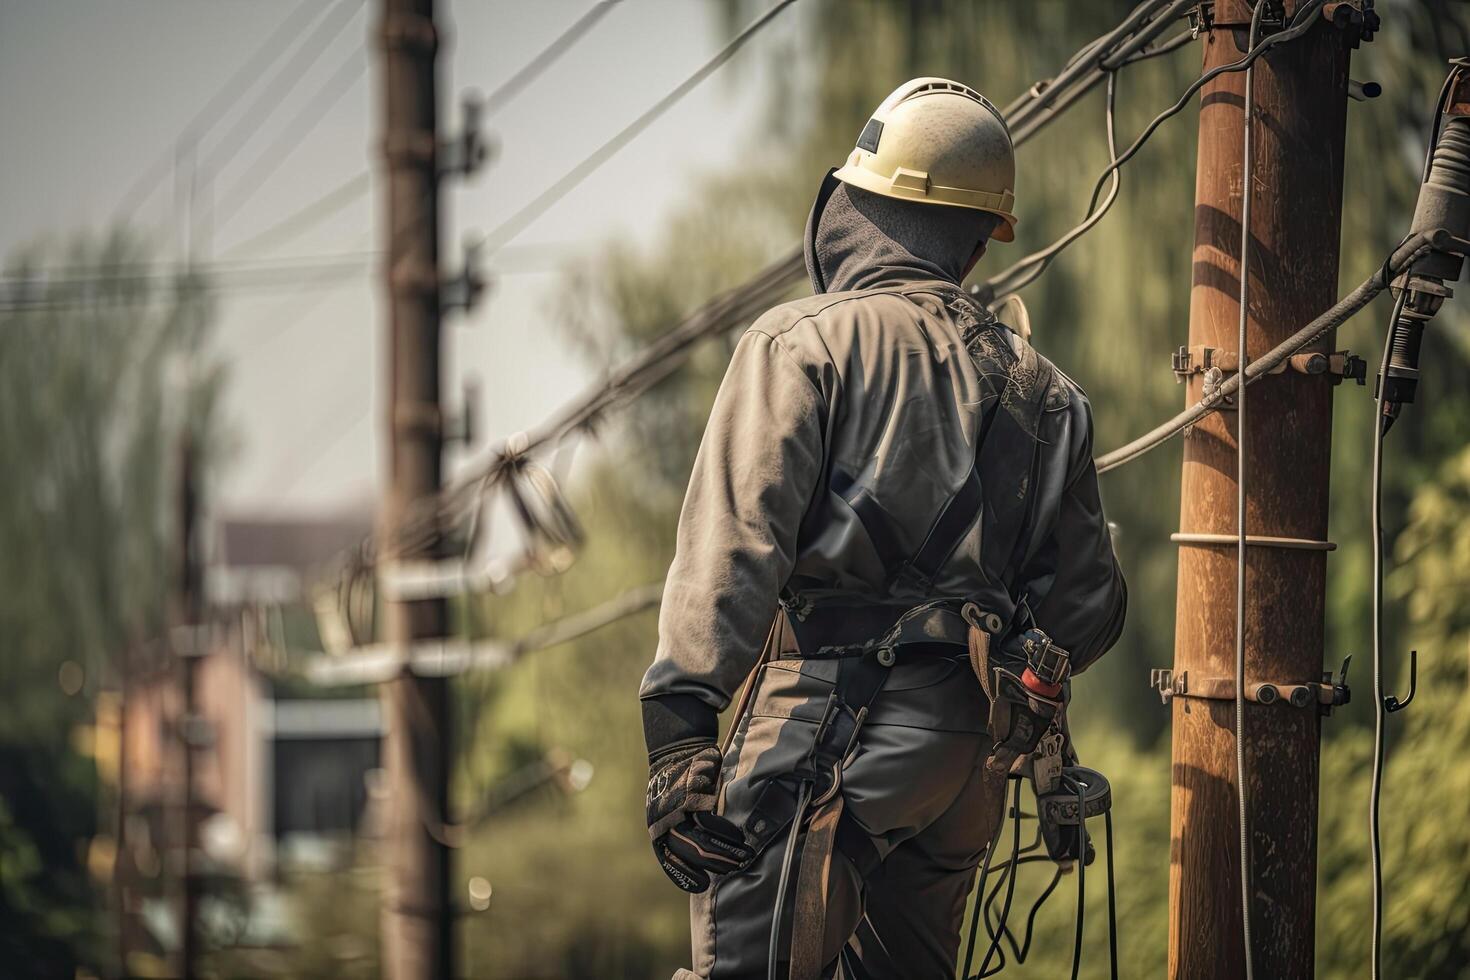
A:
<box><xmin>639</xmin><ymin>78</ymin><xmax>1126</xmax><ymax>980</ymax></box>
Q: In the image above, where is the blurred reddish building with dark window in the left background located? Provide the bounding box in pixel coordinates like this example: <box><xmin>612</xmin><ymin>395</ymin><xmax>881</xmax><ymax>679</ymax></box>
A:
<box><xmin>119</xmin><ymin>510</ymin><xmax>382</xmax><ymax>899</ymax></box>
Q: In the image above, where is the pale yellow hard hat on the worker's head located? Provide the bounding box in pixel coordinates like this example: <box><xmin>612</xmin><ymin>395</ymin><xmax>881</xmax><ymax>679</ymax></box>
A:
<box><xmin>835</xmin><ymin>78</ymin><xmax>1016</xmax><ymax>241</ymax></box>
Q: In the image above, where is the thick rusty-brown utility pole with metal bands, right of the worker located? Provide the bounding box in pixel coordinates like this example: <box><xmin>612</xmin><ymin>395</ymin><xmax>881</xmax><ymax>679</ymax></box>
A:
<box><xmin>1169</xmin><ymin>0</ymin><xmax>1351</xmax><ymax>979</ymax></box>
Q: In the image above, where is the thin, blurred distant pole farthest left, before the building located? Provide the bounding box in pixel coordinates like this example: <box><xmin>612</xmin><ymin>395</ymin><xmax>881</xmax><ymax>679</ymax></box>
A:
<box><xmin>175</xmin><ymin>428</ymin><xmax>204</xmax><ymax>980</ymax></box>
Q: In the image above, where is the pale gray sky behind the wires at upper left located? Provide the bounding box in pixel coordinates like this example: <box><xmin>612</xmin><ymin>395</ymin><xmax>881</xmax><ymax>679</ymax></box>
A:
<box><xmin>0</xmin><ymin>0</ymin><xmax>782</xmax><ymax>514</ymax></box>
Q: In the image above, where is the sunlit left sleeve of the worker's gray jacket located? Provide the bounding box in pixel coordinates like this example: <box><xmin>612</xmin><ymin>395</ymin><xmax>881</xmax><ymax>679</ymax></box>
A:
<box><xmin>639</xmin><ymin>329</ymin><xmax>825</xmax><ymax>711</ymax></box>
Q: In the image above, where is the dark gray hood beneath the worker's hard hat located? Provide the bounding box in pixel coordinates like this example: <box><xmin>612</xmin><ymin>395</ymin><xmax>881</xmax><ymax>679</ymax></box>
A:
<box><xmin>804</xmin><ymin>173</ymin><xmax>997</xmax><ymax>292</ymax></box>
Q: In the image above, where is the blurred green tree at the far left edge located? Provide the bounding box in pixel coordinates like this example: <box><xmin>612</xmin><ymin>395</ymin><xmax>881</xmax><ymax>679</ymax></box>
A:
<box><xmin>0</xmin><ymin>232</ymin><xmax>222</xmax><ymax>977</ymax></box>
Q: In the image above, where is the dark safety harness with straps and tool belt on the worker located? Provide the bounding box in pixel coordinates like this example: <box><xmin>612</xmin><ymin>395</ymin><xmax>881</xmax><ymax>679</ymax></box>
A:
<box><xmin>726</xmin><ymin>284</ymin><xmax>1099</xmax><ymax>980</ymax></box>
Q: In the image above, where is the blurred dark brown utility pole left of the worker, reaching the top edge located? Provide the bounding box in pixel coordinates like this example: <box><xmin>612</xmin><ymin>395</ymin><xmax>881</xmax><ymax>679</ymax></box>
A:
<box><xmin>379</xmin><ymin>0</ymin><xmax>454</xmax><ymax>980</ymax></box>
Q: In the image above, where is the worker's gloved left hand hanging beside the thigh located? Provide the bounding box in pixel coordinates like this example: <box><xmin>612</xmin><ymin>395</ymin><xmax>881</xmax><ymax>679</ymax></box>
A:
<box><xmin>647</xmin><ymin>739</ymin><xmax>754</xmax><ymax>893</ymax></box>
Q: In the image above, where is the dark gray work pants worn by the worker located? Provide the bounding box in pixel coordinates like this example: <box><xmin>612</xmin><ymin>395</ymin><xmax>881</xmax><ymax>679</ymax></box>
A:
<box><xmin>676</xmin><ymin>654</ymin><xmax>1005</xmax><ymax>980</ymax></box>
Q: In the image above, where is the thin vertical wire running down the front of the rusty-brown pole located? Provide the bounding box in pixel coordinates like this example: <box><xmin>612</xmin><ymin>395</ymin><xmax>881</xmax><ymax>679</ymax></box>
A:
<box><xmin>1235</xmin><ymin>0</ymin><xmax>1266</xmax><ymax>980</ymax></box>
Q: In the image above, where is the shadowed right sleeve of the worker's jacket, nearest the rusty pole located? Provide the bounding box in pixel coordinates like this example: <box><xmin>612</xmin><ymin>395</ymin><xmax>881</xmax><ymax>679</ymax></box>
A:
<box><xmin>1020</xmin><ymin>392</ymin><xmax>1127</xmax><ymax>673</ymax></box>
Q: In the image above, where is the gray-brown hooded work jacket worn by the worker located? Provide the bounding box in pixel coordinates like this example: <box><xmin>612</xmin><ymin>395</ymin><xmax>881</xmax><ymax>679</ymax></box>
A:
<box><xmin>639</xmin><ymin>178</ymin><xmax>1126</xmax><ymax>710</ymax></box>
